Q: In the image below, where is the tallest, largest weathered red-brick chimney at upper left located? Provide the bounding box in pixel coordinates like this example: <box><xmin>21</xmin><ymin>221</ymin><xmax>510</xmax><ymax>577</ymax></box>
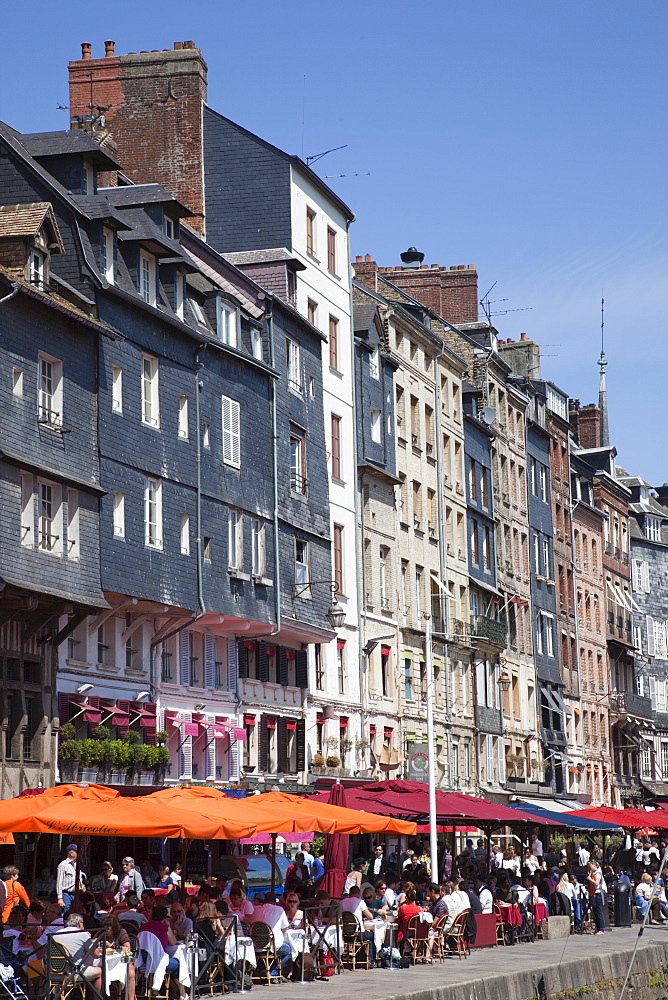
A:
<box><xmin>69</xmin><ymin>41</ymin><xmax>207</xmax><ymax>233</ymax></box>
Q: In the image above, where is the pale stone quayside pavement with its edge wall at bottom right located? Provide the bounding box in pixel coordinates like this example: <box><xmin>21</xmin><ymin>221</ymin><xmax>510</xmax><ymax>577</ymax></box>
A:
<box><xmin>260</xmin><ymin>925</ymin><xmax>668</xmax><ymax>1000</ymax></box>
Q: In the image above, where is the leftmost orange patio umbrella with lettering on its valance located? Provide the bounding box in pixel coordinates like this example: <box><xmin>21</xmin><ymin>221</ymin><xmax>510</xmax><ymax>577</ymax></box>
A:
<box><xmin>0</xmin><ymin>785</ymin><xmax>256</xmax><ymax>840</ymax></box>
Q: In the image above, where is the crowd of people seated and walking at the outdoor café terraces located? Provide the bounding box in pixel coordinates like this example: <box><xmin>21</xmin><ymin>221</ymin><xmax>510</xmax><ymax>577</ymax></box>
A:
<box><xmin>0</xmin><ymin>833</ymin><xmax>668</xmax><ymax>1000</ymax></box>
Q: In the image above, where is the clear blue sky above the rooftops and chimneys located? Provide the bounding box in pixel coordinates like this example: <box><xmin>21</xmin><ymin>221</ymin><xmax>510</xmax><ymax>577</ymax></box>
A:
<box><xmin>0</xmin><ymin>0</ymin><xmax>668</xmax><ymax>483</ymax></box>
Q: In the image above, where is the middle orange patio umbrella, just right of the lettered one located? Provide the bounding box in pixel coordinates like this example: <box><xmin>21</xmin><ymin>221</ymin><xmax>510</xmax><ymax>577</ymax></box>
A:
<box><xmin>145</xmin><ymin>785</ymin><xmax>336</xmax><ymax>839</ymax></box>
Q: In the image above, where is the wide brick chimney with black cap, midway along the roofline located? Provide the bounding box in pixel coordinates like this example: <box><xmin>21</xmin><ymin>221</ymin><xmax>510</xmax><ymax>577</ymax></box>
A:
<box><xmin>380</xmin><ymin>264</ymin><xmax>478</xmax><ymax>323</ymax></box>
